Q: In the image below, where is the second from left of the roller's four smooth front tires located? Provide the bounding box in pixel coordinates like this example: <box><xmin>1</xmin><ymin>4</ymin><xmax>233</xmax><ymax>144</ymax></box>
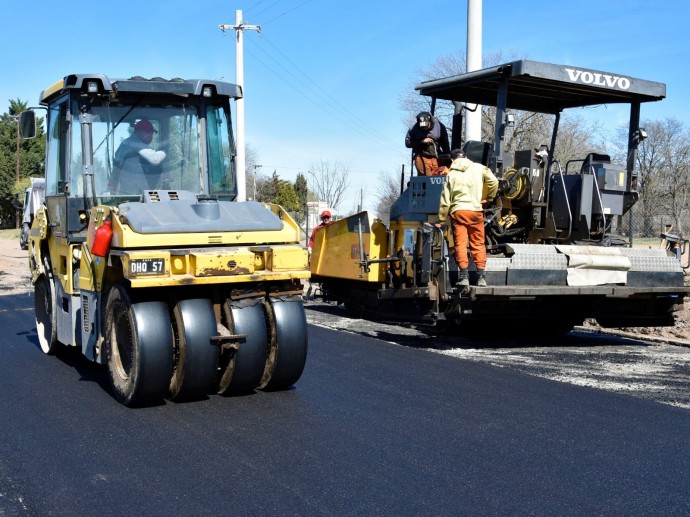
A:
<box><xmin>170</xmin><ymin>298</ymin><xmax>218</xmax><ymax>400</ymax></box>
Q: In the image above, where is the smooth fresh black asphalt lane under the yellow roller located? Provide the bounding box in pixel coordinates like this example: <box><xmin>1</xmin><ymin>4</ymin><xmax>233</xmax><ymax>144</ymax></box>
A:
<box><xmin>0</xmin><ymin>295</ymin><xmax>690</xmax><ymax>517</ymax></box>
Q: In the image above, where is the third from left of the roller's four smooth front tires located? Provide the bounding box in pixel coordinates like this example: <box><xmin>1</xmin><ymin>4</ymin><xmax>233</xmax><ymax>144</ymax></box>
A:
<box><xmin>218</xmin><ymin>298</ymin><xmax>269</xmax><ymax>394</ymax></box>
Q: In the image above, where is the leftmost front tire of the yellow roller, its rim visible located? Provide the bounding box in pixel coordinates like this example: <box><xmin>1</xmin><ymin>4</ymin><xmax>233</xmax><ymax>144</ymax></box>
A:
<box><xmin>105</xmin><ymin>284</ymin><xmax>173</xmax><ymax>406</ymax></box>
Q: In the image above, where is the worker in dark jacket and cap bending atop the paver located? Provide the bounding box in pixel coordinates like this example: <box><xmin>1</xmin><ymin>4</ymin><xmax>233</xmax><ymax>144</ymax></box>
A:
<box><xmin>405</xmin><ymin>111</ymin><xmax>450</xmax><ymax>176</ymax></box>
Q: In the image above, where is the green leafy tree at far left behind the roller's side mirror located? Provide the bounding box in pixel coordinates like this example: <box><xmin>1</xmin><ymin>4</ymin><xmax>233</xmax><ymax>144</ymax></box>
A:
<box><xmin>0</xmin><ymin>99</ymin><xmax>45</xmax><ymax>226</ymax></box>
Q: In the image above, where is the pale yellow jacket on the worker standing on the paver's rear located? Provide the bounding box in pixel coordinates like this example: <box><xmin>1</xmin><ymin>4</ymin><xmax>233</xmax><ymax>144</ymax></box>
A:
<box><xmin>438</xmin><ymin>158</ymin><xmax>498</xmax><ymax>223</ymax></box>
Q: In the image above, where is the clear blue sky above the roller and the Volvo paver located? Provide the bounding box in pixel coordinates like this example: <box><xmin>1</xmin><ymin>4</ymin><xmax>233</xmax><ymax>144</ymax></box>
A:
<box><xmin>0</xmin><ymin>0</ymin><xmax>690</xmax><ymax>212</ymax></box>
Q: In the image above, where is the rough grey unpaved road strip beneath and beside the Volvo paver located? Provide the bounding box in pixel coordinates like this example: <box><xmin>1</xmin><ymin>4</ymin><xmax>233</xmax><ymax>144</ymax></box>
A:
<box><xmin>307</xmin><ymin>300</ymin><xmax>690</xmax><ymax>409</ymax></box>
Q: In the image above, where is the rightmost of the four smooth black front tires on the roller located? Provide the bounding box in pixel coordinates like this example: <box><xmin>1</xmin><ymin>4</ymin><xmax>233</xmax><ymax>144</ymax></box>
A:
<box><xmin>261</xmin><ymin>296</ymin><xmax>307</xmax><ymax>390</ymax></box>
